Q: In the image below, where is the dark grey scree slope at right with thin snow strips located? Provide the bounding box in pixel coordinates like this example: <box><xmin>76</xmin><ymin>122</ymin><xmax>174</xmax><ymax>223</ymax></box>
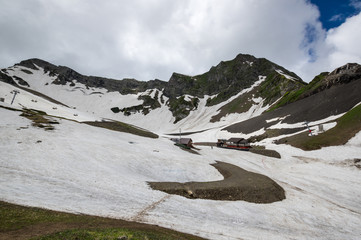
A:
<box><xmin>223</xmin><ymin>64</ymin><xmax>361</xmax><ymax>145</ymax></box>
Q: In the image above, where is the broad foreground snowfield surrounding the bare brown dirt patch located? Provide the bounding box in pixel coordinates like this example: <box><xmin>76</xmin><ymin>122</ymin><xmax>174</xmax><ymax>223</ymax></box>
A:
<box><xmin>0</xmin><ymin>108</ymin><xmax>361</xmax><ymax>239</ymax></box>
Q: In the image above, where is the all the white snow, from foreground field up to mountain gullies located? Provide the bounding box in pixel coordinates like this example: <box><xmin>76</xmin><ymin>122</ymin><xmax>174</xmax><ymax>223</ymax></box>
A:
<box><xmin>0</xmin><ymin>58</ymin><xmax>361</xmax><ymax>239</ymax></box>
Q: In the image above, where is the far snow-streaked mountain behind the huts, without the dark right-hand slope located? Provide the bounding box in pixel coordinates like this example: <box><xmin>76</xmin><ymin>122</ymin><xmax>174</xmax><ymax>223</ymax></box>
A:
<box><xmin>0</xmin><ymin>54</ymin><xmax>305</xmax><ymax>131</ymax></box>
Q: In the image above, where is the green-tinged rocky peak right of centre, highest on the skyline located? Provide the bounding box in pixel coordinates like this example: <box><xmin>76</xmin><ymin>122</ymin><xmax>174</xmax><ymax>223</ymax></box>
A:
<box><xmin>160</xmin><ymin>54</ymin><xmax>305</xmax><ymax>122</ymax></box>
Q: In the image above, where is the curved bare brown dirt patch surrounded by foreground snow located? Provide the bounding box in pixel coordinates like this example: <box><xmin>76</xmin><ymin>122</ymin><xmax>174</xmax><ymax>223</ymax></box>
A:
<box><xmin>149</xmin><ymin>162</ymin><xmax>286</xmax><ymax>203</ymax></box>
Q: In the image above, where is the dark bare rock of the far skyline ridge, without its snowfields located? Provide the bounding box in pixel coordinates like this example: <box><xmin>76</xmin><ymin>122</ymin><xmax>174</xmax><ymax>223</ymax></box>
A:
<box><xmin>4</xmin><ymin>54</ymin><xmax>305</xmax><ymax>123</ymax></box>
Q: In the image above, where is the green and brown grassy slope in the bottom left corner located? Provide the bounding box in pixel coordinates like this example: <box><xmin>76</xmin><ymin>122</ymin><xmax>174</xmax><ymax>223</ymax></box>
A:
<box><xmin>0</xmin><ymin>201</ymin><xmax>202</xmax><ymax>240</ymax></box>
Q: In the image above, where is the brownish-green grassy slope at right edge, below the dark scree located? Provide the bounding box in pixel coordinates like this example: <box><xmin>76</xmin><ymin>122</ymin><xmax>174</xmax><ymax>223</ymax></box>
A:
<box><xmin>279</xmin><ymin>105</ymin><xmax>361</xmax><ymax>150</ymax></box>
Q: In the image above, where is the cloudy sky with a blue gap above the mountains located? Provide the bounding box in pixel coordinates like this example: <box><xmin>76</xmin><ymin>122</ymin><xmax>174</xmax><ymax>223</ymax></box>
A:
<box><xmin>0</xmin><ymin>0</ymin><xmax>361</xmax><ymax>82</ymax></box>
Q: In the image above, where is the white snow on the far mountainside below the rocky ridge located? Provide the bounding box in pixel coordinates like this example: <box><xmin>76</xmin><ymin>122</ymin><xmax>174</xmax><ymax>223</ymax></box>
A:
<box><xmin>2</xmin><ymin>65</ymin><xmax>268</xmax><ymax>134</ymax></box>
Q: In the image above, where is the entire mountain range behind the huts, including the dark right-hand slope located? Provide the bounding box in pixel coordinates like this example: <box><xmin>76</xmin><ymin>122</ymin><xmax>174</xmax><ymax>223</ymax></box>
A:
<box><xmin>0</xmin><ymin>54</ymin><xmax>361</xmax><ymax>146</ymax></box>
